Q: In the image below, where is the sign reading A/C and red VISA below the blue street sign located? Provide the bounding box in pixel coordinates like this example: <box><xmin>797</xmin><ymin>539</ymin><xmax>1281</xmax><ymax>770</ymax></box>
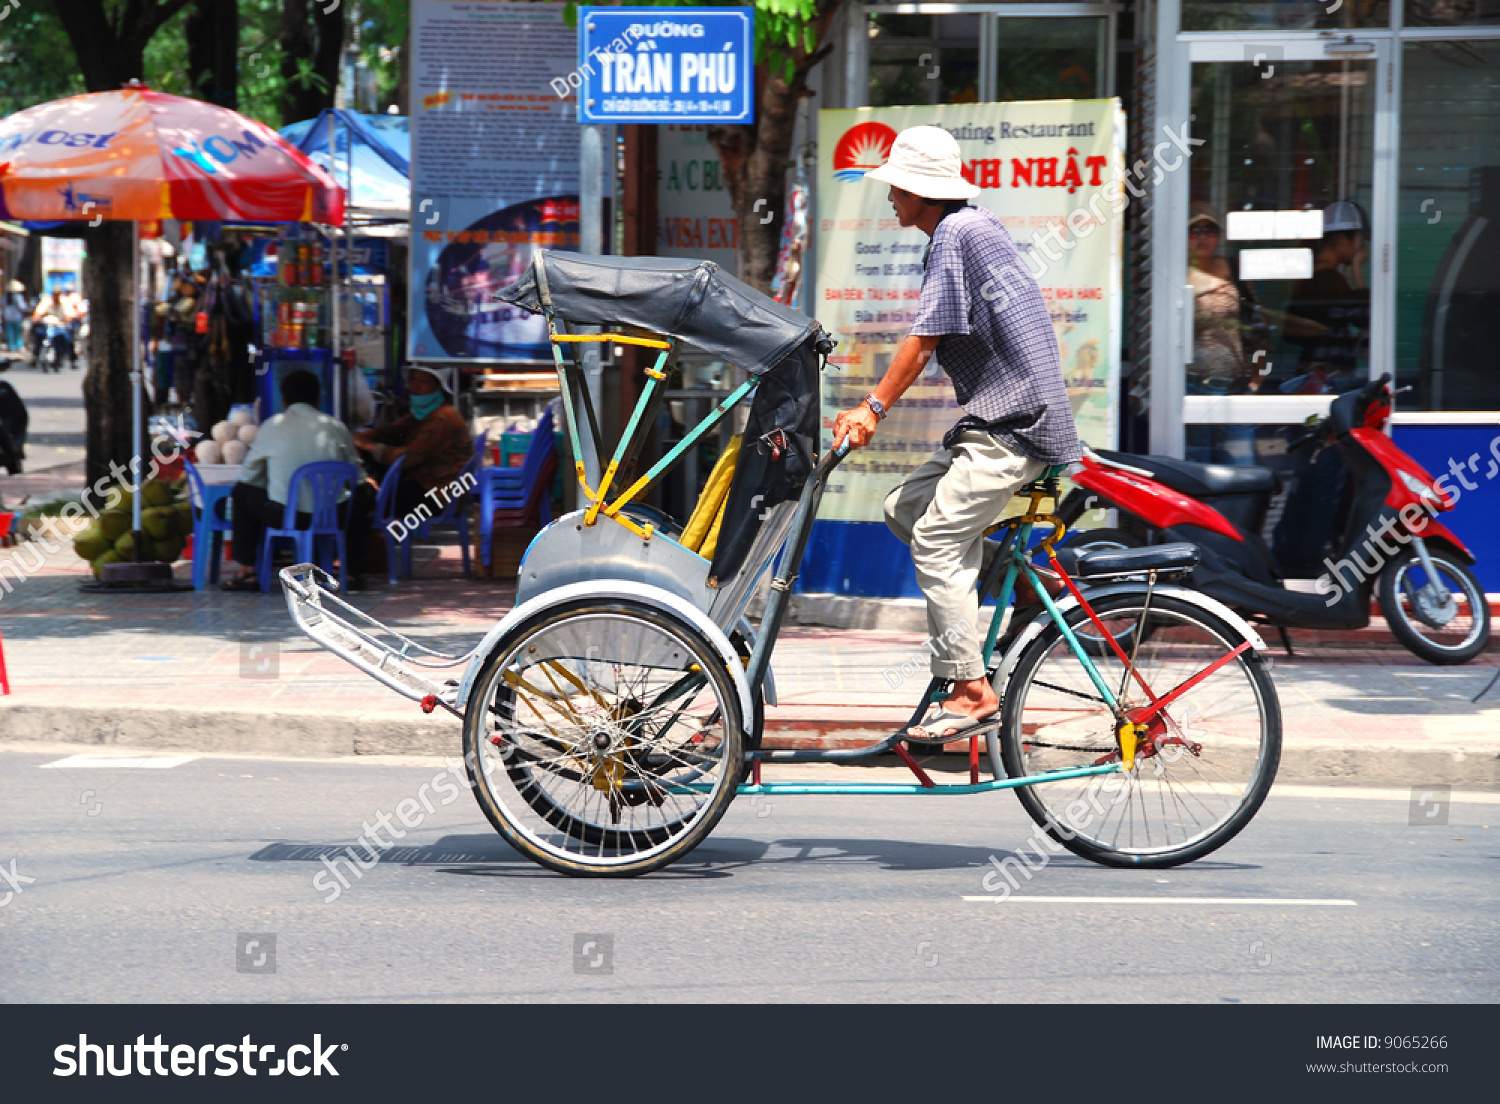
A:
<box><xmin>657</xmin><ymin>123</ymin><xmax>740</xmax><ymax>276</ymax></box>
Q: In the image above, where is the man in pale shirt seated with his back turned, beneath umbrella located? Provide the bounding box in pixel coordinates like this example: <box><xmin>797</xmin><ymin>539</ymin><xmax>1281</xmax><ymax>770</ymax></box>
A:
<box><xmin>221</xmin><ymin>372</ymin><xmax>375</xmax><ymax>591</ymax></box>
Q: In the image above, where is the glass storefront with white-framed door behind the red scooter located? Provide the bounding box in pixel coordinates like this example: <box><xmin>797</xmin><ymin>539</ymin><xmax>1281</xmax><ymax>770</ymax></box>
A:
<box><xmin>821</xmin><ymin>0</ymin><xmax>1500</xmax><ymax>593</ymax></box>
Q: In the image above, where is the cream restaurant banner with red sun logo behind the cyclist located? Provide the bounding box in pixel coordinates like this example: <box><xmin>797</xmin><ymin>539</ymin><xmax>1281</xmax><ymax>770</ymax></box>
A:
<box><xmin>809</xmin><ymin>99</ymin><xmax>1128</xmax><ymax>522</ymax></box>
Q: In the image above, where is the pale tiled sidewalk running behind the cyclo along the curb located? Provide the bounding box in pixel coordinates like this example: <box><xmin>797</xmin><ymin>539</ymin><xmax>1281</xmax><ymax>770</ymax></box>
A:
<box><xmin>0</xmin><ymin>531</ymin><xmax>1500</xmax><ymax>783</ymax></box>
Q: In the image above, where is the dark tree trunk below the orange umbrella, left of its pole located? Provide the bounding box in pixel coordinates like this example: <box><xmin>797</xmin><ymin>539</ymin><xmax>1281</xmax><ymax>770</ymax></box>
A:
<box><xmin>84</xmin><ymin>222</ymin><xmax>135</xmax><ymax>485</ymax></box>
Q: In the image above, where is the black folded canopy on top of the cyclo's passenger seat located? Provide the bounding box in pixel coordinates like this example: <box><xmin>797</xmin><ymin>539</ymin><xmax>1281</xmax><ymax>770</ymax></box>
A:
<box><xmin>500</xmin><ymin>251</ymin><xmax>821</xmax><ymax>375</ymax></box>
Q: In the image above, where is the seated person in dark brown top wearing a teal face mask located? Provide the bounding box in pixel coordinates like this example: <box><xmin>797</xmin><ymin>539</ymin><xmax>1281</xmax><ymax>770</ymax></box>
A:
<box><xmin>354</xmin><ymin>365</ymin><xmax>474</xmax><ymax>518</ymax></box>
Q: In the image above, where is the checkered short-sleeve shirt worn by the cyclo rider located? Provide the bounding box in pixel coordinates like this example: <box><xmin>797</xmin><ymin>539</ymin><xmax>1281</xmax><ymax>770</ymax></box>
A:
<box><xmin>912</xmin><ymin>207</ymin><xmax>1080</xmax><ymax>464</ymax></box>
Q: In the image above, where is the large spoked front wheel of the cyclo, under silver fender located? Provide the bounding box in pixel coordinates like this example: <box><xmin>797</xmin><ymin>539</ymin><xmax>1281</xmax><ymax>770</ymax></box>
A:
<box><xmin>464</xmin><ymin>599</ymin><xmax>744</xmax><ymax>878</ymax></box>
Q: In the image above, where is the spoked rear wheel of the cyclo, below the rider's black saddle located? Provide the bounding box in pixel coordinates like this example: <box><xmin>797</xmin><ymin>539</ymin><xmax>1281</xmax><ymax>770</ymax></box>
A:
<box><xmin>989</xmin><ymin>588</ymin><xmax>1281</xmax><ymax>867</ymax></box>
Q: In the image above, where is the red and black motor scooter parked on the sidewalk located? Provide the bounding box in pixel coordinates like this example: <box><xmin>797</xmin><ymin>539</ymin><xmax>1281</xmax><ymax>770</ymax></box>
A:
<box><xmin>1058</xmin><ymin>375</ymin><xmax>1490</xmax><ymax>665</ymax></box>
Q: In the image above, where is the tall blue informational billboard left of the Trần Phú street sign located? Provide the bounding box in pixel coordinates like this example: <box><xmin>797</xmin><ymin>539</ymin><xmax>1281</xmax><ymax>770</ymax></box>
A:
<box><xmin>408</xmin><ymin>0</ymin><xmax>579</xmax><ymax>362</ymax></box>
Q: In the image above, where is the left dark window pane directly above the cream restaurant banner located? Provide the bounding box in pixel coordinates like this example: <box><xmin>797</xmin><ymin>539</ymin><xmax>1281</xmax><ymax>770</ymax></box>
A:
<box><xmin>869</xmin><ymin>12</ymin><xmax>980</xmax><ymax>108</ymax></box>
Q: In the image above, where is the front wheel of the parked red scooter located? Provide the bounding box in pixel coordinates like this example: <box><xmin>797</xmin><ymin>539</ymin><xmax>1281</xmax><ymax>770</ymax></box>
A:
<box><xmin>1376</xmin><ymin>546</ymin><xmax>1490</xmax><ymax>666</ymax></box>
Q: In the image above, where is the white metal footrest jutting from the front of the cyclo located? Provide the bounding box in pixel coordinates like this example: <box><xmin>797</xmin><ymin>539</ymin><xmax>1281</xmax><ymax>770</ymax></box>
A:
<box><xmin>281</xmin><ymin>564</ymin><xmax>473</xmax><ymax>708</ymax></box>
